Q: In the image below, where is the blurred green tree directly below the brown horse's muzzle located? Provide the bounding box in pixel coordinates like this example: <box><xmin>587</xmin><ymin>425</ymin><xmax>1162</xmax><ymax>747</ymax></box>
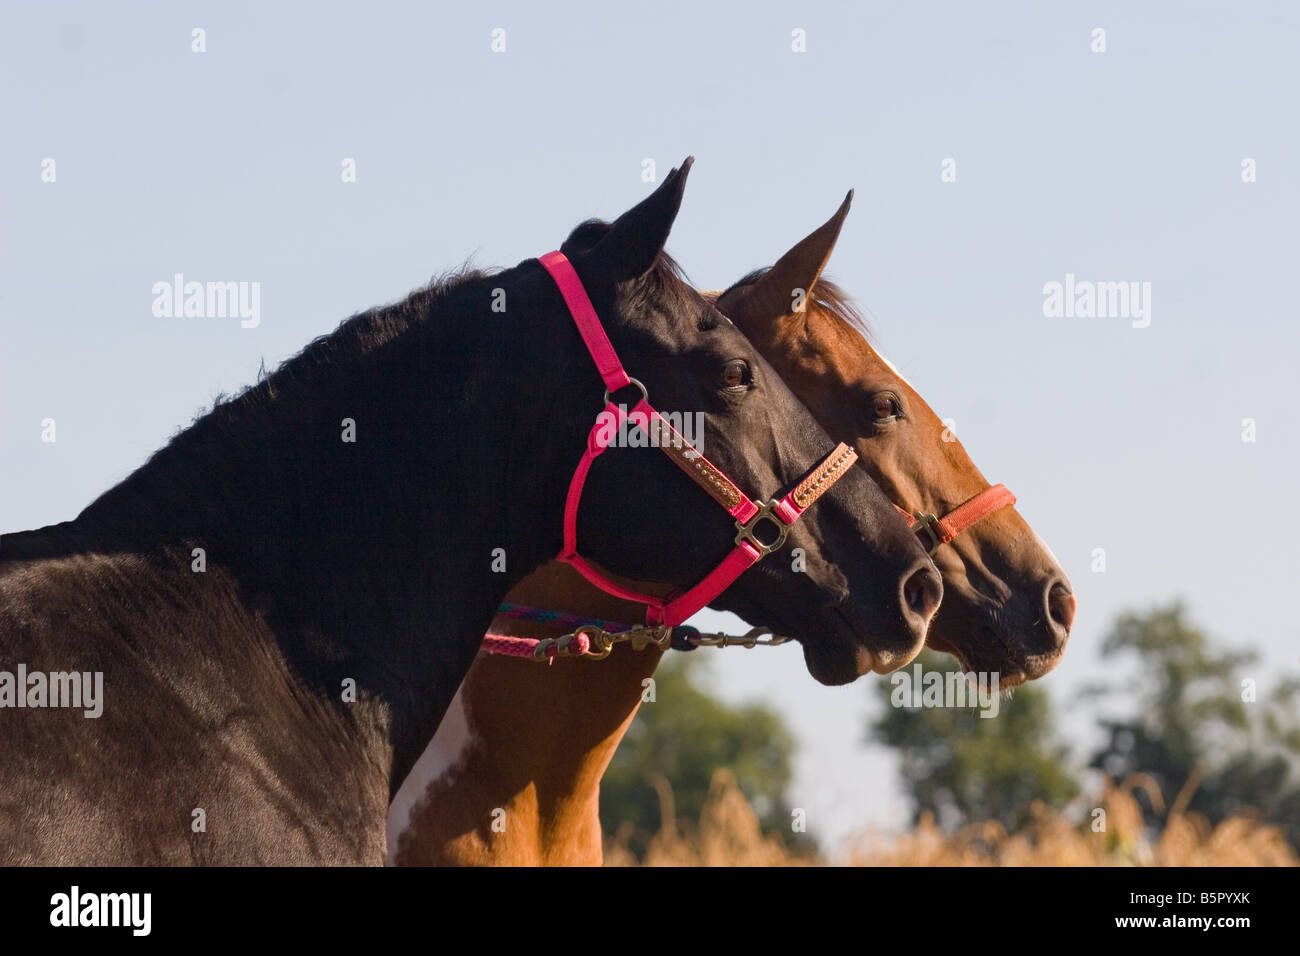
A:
<box><xmin>868</xmin><ymin>650</ymin><xmax>1078</xmax><ymax>831</ymax></box>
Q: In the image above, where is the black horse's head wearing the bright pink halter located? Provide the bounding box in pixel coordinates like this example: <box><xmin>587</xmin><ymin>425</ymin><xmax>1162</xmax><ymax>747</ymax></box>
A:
<box><xmin>543</xmin><ymin>160</ymin><xmax>943</xmax><ymax>683</ymax></box>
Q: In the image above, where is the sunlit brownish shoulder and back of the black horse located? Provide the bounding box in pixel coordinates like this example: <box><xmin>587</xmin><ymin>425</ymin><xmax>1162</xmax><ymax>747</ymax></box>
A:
<box><xmin>0</xmin><ymin>523</ymin><xmax>387</xmax><ymax>865</ymax></box>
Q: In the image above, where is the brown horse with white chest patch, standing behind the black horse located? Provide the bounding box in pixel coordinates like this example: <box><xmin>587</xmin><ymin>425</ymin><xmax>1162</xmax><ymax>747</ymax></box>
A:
<box><xmin>389</xmin><ymin>193</ymin><xmax>1074</xmax><ymax>865</ymax></box>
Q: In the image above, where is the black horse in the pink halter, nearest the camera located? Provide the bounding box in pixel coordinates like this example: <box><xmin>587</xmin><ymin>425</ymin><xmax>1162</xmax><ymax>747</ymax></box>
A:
<box><xmin>0</xmin><ymin>161</ymin><xmax>940</xmax><ymax>864</ymax></box>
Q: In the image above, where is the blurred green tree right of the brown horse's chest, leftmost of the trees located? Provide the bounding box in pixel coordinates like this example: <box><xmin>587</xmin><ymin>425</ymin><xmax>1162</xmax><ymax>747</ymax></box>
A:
<box><xmin>601</xmin><ymin>652</ymin><xmax>806</xmax><ymax>857</ymax></box>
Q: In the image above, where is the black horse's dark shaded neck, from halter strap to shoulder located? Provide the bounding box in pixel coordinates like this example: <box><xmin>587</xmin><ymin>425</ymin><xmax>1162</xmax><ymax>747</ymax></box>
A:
<box><xmin>78</xmin><ymin>263</ymin><xmax>601</xmax><ymax>788</ymax></box>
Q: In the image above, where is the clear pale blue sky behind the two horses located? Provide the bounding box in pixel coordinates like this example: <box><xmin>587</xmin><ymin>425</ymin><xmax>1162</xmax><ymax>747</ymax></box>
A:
<box><xmin>0</xmin><ymin>3</ymin><xmax>1300</xmax><ymax>853</ymax></box>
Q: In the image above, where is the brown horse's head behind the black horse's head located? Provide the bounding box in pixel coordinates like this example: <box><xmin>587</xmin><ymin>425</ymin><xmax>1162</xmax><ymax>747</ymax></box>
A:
<box><xmin>718</xmin><ymin>193</ymin><xmax>1075</xmax><ymax>687</ymax></box>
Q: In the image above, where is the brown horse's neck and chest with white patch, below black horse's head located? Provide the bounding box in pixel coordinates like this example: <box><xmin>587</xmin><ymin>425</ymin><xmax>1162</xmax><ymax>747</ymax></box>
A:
<box><xmin>389</xmin><ymin>563</ymin><xmax>660</xmax><ymax>865</ymax></box>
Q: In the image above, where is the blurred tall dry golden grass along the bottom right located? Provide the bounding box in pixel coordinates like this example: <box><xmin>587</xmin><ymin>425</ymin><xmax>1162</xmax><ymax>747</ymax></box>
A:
<box><xmin>605</xmin><ymin>770</ymin><xmax>1300</xmax><ymax>866</ymax></box>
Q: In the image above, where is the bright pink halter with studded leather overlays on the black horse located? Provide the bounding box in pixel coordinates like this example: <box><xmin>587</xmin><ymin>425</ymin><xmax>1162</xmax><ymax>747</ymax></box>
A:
<box><xmin>538</xmin><ymin>252</ymin><xmax>858</xmax><ymax>627</ymax></box>
